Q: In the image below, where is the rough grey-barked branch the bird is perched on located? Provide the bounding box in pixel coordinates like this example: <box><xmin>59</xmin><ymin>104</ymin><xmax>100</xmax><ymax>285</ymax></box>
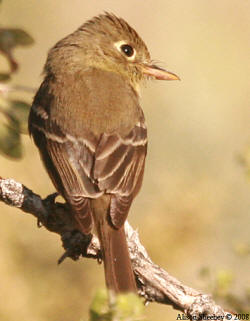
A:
<box><xmin>0</xmin><ymin>178</ymin><xmax>232</xmax><ymax>320</ymax></box>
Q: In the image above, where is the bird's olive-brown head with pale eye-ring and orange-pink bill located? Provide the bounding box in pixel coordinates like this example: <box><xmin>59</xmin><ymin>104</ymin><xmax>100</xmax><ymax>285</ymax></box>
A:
<box><xmin>46</xmin><ymin>13</ymin><xmax>179</xmax><ymax>86</ymax></box>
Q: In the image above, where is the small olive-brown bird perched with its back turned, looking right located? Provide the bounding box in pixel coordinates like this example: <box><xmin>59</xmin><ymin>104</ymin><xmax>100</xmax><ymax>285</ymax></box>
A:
<box><xmin>29</xmin><ymin>13</ymin><xmax>179</xmax><ymax>294</ymax></box>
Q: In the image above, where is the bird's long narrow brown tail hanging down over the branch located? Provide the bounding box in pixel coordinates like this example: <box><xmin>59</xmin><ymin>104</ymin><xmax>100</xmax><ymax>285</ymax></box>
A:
<box><xmin>91</xmin><ymin>196</ymin><xmax>137</xmax><ymax>293</ymax></box>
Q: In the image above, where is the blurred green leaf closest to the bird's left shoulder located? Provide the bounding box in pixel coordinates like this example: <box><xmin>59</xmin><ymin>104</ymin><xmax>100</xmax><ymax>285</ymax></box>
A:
<box><xmin>6</xmin><ymin>100</ymin><xmax>30</xmax><ymax>134</ymax></box>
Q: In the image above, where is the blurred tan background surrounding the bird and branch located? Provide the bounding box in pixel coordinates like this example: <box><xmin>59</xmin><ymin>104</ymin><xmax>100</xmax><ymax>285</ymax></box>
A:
<box><xmin>0</xmin><ymin>0</ymin><xmax>250</xmax><ymax>321</ymax></box>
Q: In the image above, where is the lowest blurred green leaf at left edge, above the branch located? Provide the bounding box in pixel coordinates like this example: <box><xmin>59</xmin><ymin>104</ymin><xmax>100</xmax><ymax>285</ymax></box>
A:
<box><xmin>0</xmin><ymin>123</ymin><xmax>22</xmax><ymax>158</ymax></box>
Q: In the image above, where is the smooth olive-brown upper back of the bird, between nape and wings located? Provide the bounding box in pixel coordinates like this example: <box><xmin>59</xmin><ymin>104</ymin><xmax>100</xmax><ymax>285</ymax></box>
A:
<box><xmin>51</xmin><ymin>68</ymin><xmax>142</xmax><ymax>136</ymax></box>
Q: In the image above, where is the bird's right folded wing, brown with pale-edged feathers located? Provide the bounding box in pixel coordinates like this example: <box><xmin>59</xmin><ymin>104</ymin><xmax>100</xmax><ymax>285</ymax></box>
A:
<box><xmin>93</xmin><ymin>119</ymin><xmax>147</xmax><ymax>228</ymax></box>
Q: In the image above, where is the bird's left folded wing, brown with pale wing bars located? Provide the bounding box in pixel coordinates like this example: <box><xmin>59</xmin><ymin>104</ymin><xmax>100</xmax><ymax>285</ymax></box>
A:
<box><xmin>29</xmin><ymin>104</ymin><xmax>103</xmax><ymax>234</ymax></box>
